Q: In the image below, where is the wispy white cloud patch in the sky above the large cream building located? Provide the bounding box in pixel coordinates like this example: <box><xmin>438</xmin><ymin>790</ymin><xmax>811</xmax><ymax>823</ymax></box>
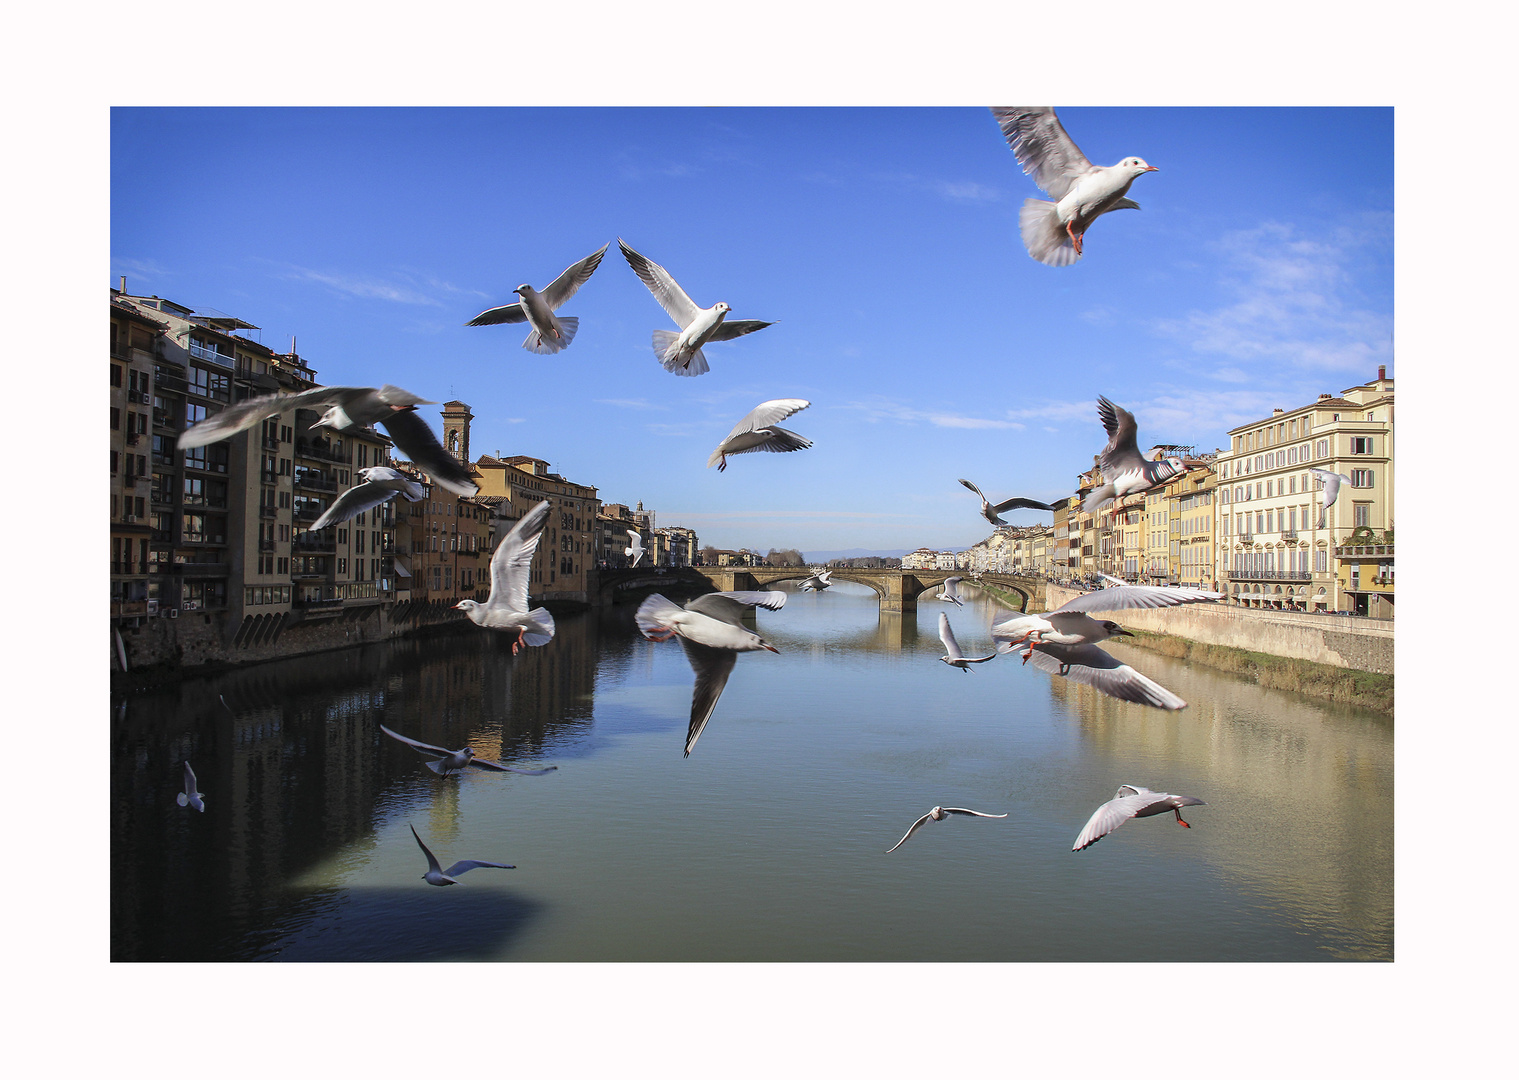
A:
<box><xmin>1153</xmin><ymin>216</ymin><xmax>1393</xmax><ymax>381</ymax></box>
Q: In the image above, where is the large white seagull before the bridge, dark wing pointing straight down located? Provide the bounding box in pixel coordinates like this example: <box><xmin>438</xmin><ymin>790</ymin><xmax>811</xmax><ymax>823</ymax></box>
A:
<box><xmin>635</xmin><ymin>591</ymin><xmax>785</xmax><ymax>756</ymax></box>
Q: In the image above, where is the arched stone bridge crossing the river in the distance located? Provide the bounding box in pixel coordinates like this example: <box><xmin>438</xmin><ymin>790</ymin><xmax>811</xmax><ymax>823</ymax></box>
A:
<box><xmin>597</xmin><ymin>567</ymin><xmax>1045</xmax><ymax>612</ymax></box>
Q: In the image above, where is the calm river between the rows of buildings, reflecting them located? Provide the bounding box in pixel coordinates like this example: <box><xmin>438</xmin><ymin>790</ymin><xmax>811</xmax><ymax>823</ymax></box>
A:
<box><xmin>111</xmin><ymin>583</ymin><xmax>1393</xmax><ymax>962</ymax></box>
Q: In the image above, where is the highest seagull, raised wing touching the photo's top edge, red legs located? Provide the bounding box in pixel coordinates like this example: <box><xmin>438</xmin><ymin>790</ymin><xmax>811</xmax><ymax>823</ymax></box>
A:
<box><xmin>992</xmin><ymin>105</ymin><xmax>1157</xmax><ymax>266</ymax></box>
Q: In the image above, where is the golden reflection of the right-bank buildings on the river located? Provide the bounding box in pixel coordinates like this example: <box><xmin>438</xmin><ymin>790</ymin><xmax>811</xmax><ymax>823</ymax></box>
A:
<box><xmin>1039</xmin><ymin>643</ymin><xmax>1393</xmax><ymax>948</ymax></box>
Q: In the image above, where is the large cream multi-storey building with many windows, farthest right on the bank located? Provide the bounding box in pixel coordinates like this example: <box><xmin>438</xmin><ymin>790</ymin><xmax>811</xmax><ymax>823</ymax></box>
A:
<box><xmin>1217</xmin><ymin>368</ymin><xmax>1394</xmax><ymax>617</ymax></box>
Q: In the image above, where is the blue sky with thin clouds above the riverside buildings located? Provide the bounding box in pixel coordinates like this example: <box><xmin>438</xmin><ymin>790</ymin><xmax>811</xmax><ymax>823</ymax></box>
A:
<box><xmin>109</xmin><ymin>108</ymin><xmax>1396</xmax><ymax>551</ymax></box>
